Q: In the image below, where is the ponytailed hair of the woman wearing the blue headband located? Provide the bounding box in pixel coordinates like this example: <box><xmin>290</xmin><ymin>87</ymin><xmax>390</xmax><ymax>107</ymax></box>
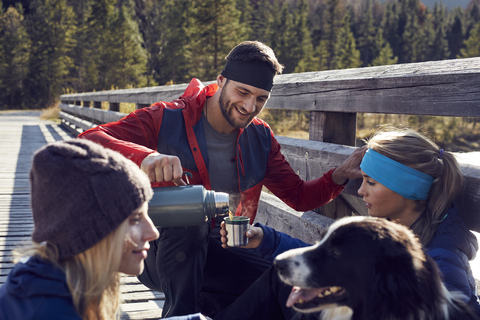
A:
<box><xmin>366</xmin><ymin>127</ymin><xmax>464</xmax><ymax>245</ymax></box>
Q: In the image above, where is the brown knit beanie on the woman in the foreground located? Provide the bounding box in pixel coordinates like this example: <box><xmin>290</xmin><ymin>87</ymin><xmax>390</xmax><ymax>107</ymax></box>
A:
<box><xmin>30</xmin><ymin>139</ymin><xmax>152</xmax><ymax>260</ymax></box>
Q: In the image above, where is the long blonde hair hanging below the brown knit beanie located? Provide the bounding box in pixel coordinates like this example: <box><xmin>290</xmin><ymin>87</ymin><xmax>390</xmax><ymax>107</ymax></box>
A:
<box><xmin>14</xmin><ymin>220</ymin><xmax>128</xmax><ymax>320</ymax></box>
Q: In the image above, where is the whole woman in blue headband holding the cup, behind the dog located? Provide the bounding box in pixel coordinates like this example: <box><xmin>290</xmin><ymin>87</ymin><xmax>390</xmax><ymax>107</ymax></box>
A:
<box><xmin>214</xmin><ymin>129</ymin><xmax>480</xmax><ymax>320</ymax></box>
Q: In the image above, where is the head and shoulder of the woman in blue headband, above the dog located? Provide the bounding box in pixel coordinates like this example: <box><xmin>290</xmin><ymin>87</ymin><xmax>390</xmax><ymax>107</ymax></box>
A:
<box><xmin>358</xmin><ymin>130</ymin><xmax>480</xmax><ymax>310</ymax></box>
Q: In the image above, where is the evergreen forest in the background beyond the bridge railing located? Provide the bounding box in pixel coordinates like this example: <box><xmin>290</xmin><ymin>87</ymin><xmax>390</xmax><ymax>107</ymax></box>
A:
<box><xmin>0</xmin><ymin>0</ymin><xmax>480</xmax><ymax>109</ymax></box>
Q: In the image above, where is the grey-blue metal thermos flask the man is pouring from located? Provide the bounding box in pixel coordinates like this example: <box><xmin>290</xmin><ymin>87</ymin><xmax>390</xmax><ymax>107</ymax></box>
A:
<box><xmin>148</xmin><ymin>185</ymin><xmax>229</xmax><ymax>227</ymax></box>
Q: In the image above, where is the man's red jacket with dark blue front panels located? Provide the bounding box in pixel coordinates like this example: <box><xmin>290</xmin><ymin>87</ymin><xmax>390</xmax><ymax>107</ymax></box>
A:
<box><xmin>79</xmin><ymin>79</ymin><xmax>344</xmax><ymax>222</ymax></box>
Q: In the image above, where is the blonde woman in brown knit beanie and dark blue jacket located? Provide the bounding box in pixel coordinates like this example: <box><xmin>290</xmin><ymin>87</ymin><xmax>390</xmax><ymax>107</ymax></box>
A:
<box><xmin>0</xmin><ymin>140</ymin><xmax>158</xmax><ymax>320</ymax></box>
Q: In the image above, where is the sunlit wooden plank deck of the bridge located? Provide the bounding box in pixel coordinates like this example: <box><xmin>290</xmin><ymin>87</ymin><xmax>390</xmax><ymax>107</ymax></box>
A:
<box><xmin>0</xmin><ymin>111</ymin><xmax>164</xmax><ymax>320</ymax></box>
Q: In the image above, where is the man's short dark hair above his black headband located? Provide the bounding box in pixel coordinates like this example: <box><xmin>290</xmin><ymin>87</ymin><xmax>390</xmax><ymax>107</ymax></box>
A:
<box><xmin>225</xmin><ymin>41</ymin><xmax>284</xmax><ymax>74</ymax></box>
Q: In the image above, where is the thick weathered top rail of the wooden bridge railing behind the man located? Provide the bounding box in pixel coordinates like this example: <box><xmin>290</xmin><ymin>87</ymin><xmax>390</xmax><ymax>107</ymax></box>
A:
<box><xmin>61</xmin><ymin>58</ymin><xmax>480</xmax><ymax>117</ymax></box>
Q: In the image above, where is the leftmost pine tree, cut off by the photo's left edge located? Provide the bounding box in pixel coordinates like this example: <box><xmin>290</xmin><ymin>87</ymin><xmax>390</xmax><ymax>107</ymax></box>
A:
<box><xmin>0</xmin><ymin>2</ymin><xmax>30</xmax><ymax>109</ymax></box>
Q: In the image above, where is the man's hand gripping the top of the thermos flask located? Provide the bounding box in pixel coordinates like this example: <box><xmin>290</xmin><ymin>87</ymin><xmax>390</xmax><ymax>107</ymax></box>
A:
<box><xmin>140</xmin><ymin>152</ymin><xmax>186</xmax><ymax>186</ymax></box>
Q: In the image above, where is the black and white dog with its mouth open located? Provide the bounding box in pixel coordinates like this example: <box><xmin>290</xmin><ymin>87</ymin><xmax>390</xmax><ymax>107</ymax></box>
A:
<box><xmin>275</xmin><ymin>217</ymin><xmax>478</xmax><ymax>320</ymax></box>
